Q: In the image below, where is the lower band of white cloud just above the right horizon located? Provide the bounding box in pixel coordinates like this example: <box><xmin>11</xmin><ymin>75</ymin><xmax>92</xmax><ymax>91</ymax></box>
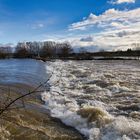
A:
<box><xmin>71</xmin><ymin>27</ymin><xmax>140</xmax><ymax>51</ymax></box>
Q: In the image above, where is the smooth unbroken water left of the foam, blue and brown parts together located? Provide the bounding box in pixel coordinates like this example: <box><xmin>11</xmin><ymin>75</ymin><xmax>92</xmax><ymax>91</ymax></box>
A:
<box><xmin>0</xmin><ymin>59</ymin><xmax>84</xmax><ymax>140</ymax></box>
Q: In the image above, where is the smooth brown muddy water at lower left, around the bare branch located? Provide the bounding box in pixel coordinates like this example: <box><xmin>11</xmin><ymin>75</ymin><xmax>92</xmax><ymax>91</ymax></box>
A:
<box><xmin>0</xmin><ymin>65</ymin><xmax>84</xmax><ymax>140</ymax></box>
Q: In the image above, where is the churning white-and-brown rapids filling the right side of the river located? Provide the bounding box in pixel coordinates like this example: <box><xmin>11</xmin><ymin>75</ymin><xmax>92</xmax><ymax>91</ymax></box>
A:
<box><xmin>42</xmin><ymin>60</ymin><xmax>140</xmax><ymax>140</ymax></box>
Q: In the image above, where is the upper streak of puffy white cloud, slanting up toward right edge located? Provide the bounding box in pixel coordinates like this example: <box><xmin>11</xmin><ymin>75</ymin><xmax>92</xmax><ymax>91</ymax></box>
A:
<box><xmin>69</xmin><ymin>8</ymin><xmax>140</xmax><ymax>30</ymax></box>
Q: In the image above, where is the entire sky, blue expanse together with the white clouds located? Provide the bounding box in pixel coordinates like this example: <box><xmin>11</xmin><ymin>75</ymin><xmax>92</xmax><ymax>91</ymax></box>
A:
<box><xmin>0</xmin><ymin>0</ymin><xmax>140</xmax><ymax>51</ymax></box>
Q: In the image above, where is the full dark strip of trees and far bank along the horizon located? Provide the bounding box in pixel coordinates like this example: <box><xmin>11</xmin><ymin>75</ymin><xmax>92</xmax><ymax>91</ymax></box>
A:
<box><xmin>0</xmin><ymin>41</ymin><xmax>140</xmax><ymax>61</ymax></box>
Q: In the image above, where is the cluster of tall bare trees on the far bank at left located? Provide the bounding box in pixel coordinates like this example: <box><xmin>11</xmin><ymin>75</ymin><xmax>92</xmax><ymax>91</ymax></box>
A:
<box><xmin>0</xmin><ymin>41</ymin><xmax>73</xmax><ymax>59</ymax></box>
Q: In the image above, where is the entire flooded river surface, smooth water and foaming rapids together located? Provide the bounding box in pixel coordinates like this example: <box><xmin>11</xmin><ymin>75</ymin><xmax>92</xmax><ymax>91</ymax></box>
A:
<box><xmin>0</xmin><ymin>59</ymin><xmax>140</xmax><ymax>140</ymax></box>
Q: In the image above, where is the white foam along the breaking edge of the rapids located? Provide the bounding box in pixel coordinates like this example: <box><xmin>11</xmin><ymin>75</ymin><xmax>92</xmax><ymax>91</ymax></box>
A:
<box><xmin>42</xmin><ymin>61</ymin><xmax>140</xmax><ymax>140</ymax></box>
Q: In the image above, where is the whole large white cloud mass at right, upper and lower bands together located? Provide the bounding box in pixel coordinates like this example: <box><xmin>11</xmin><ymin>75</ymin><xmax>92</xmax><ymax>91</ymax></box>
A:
<box><xmin>69</xmin><ymin>8</ymin><xmax>140</xmax><ymax>50</ymax></box>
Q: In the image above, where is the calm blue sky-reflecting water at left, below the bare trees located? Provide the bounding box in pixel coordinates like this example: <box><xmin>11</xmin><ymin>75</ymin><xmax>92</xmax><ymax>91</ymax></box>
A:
<box><xmin>0</xmin><ymin>59</ymin><xmax>47</xmax><ymax>86</ymax></box>
